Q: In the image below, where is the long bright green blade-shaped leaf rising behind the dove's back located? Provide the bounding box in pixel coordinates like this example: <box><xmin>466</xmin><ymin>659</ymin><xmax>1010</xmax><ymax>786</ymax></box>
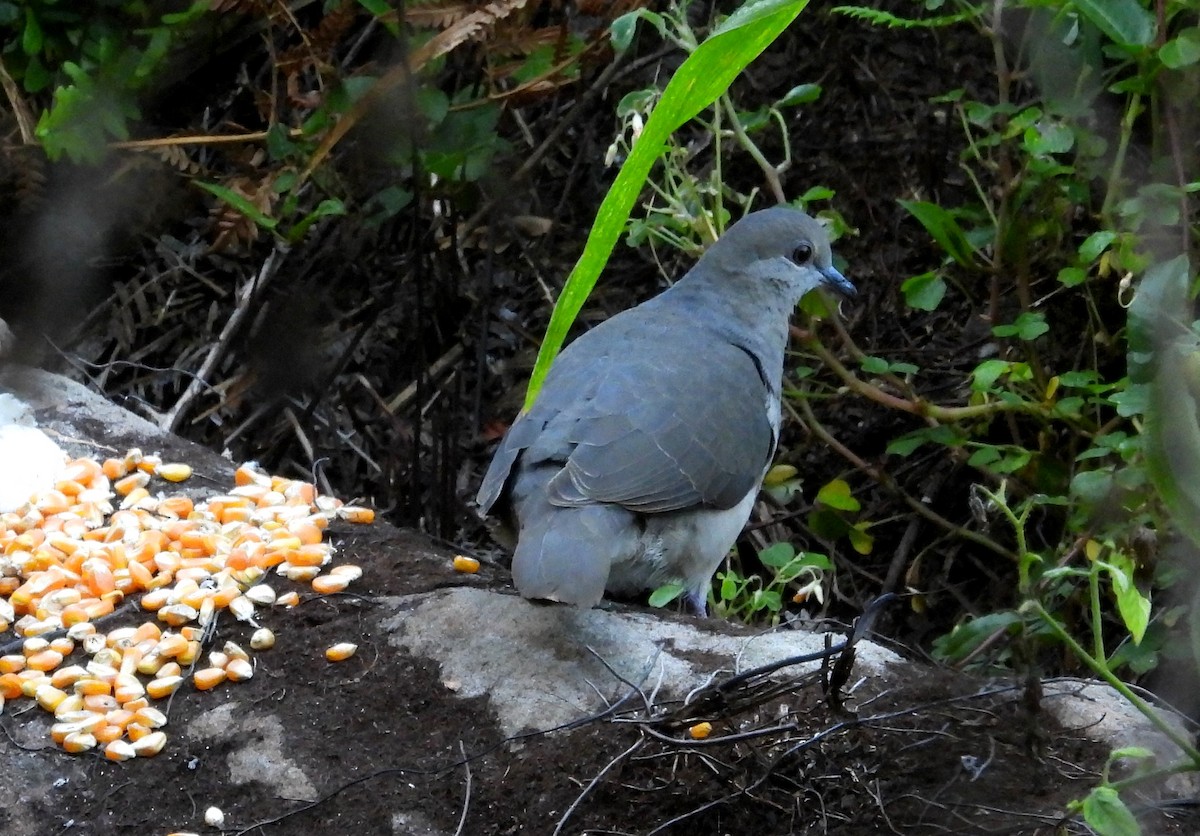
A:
<box><xmin>524</xmin><ymin>0</ymin><xmax>808</xmax><ymax>409</ymax></box>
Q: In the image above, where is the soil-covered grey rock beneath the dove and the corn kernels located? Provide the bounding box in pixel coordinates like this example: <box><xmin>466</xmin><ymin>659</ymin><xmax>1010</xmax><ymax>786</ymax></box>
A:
<box><xmin>0</xmin><ymin>369</ymin><xmax>1194</xmax><ymax>836</ymax></box>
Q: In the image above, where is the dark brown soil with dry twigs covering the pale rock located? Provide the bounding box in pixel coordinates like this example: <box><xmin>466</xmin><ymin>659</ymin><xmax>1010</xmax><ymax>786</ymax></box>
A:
<box><xmin>7</xmin><ymin>508</ymin><xmax>1196</xmax><ymax>836</ymax></box>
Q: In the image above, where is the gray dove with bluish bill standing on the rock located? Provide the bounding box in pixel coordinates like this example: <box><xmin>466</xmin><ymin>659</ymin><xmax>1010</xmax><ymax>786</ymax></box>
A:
<box><xmin>478</xmin><ymin>206</ymin><xmax>854</xmax><ymax>614</ymax></box>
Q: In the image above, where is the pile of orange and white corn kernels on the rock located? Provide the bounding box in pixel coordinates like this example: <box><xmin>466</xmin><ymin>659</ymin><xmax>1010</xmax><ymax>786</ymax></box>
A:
<box><xmin>0</xmin><ymin>450</ymin><xmax>374</xmax><ymax>760</ymax></box>
